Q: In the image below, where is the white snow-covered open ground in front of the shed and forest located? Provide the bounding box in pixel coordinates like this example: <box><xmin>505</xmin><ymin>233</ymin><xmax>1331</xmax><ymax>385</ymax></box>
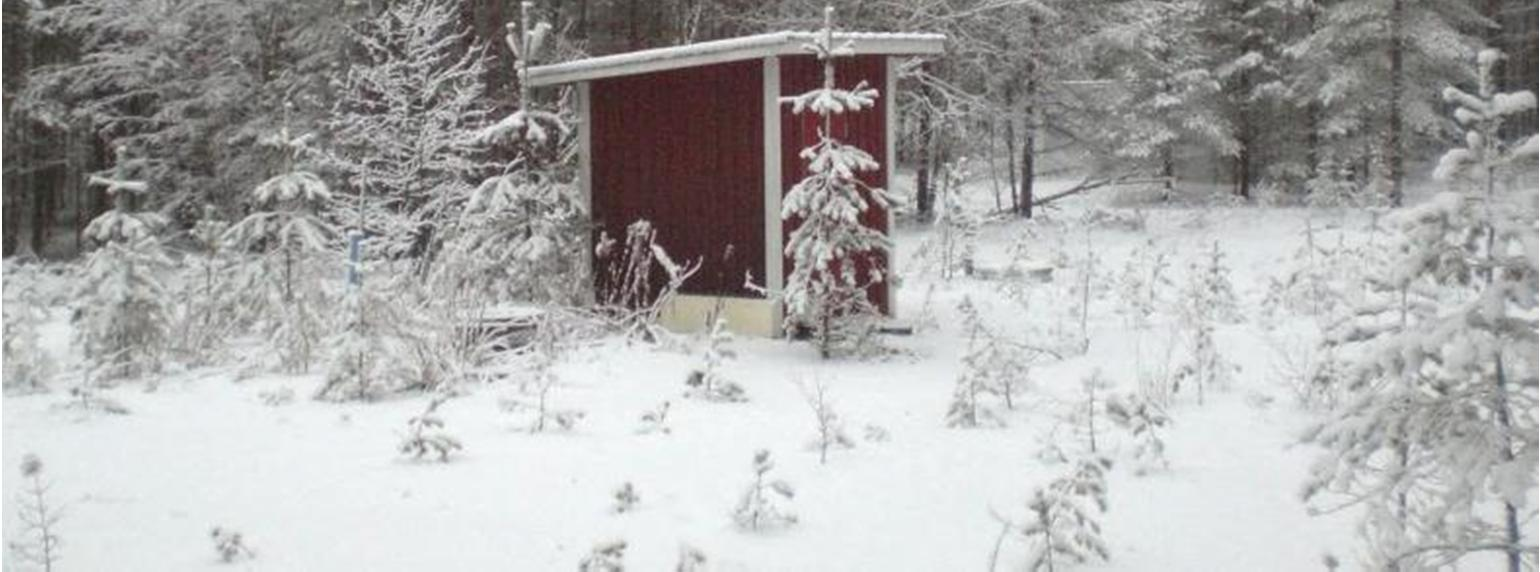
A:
<box><xmin>3</xmin><ymin>185</ymin><xmax>1369</xmax><ymax>570</ymax></box>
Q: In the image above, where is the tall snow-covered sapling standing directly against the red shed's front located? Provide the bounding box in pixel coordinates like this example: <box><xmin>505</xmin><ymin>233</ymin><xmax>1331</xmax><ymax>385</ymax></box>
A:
<box><xmin>781</xmin><ymin>6</ymin><xmax>890</xmax><ymax>358</ymax></box>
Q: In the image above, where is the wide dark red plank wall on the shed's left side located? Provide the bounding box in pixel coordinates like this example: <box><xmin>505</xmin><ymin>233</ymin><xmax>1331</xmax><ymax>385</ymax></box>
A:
<box><xmin>590</xmin><ymin>60</ymin><xmax>765</xmax><ymax>305</ymax></box>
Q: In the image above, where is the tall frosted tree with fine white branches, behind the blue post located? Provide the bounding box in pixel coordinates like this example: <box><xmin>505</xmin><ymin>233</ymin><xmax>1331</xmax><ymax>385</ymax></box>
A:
<box><xmin>330</xmin><ymin>0</ymin><xmax>487</xmax><ymax>264</ymax></box>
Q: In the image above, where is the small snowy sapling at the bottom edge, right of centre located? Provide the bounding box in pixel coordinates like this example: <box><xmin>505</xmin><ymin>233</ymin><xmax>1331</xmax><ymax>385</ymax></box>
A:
<box><xmin>1016</xmin><ymin>459</ymin><xmax>1110</xmax><ymax>572</ymax></box>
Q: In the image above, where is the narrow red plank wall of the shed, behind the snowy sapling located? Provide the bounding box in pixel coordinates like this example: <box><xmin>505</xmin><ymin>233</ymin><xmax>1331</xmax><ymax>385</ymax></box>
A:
<box><xmin>781</xmin><ymin>56</ymin><xmax>890</xmax><ymax>313</ymax></box>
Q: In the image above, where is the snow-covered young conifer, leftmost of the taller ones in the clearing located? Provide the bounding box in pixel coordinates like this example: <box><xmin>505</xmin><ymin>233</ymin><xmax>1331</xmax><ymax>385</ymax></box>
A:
<box><xmin>74</xmin><ymin>148</ymin><xmax>174</xmax><ymax>381</ymax></box>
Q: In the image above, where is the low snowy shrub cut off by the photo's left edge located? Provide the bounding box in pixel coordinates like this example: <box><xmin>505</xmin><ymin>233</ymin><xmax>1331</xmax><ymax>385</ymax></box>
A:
<box><xmin>0</xmin><ymin>261</ymin><xmax>54</xmax><ymax>393</ymax></box>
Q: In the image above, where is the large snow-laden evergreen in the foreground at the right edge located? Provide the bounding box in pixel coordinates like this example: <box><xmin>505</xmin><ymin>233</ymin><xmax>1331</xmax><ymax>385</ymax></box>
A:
<box><xmin>1304</xmin><ymin>51</ymin><xmax>1540</xmax><ymax>570</ymax></box>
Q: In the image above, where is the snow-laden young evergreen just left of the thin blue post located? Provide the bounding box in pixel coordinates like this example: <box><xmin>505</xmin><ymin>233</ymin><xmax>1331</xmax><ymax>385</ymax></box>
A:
<box><xmin>225</xmin><ymin>126</ymin><xmax>342</xmax><ymax>372</ymax></box>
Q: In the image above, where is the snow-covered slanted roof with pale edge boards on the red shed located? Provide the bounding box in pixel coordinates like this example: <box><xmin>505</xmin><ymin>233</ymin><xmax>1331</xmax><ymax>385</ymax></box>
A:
<box><xmin>528</xmin><ymin>31</ymin><xmax>947</xmax><ymax>88</ymax></box>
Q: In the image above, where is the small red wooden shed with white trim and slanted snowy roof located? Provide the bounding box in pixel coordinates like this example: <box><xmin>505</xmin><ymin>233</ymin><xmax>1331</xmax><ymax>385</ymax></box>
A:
<box><xmin>527</xmin><ymin>32</ymin><xmax>946</xmax><ymax>336</ymax></box>
